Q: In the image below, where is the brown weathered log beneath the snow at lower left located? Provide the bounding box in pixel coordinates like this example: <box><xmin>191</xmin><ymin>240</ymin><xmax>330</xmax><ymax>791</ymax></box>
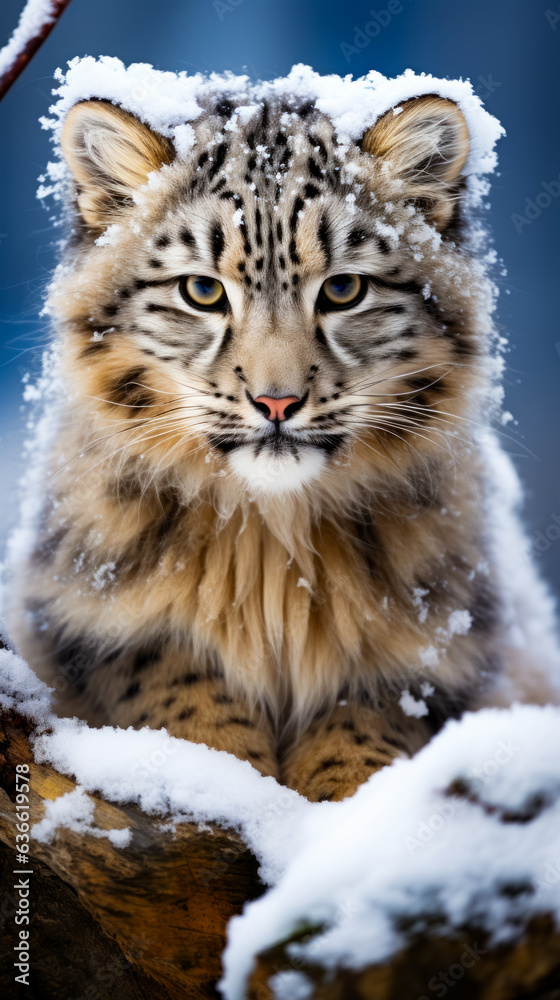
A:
<box><xmin>0</xmin><ymin>713</ymin><xmax>262</xmax><ymax>1000</ymax></box>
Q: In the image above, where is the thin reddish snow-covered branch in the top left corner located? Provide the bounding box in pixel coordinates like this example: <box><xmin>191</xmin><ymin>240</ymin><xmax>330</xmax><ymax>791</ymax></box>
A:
<box><xmin>0</xmin><ymin>0</ymin><xmax>70</xmax><ymax>100</ymax></box>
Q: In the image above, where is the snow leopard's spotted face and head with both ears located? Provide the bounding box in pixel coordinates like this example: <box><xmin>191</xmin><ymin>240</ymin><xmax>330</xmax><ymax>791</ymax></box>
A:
<box><xmin>55</xmin><ymin>89</ymin><xmax>488</xmax><ymax>496</ymax></box>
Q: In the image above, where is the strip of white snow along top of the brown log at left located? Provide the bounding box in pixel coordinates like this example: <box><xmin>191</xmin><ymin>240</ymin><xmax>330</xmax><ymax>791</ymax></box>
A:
<box><xmin>0</xmin><ymin>650</ymin><xmax>310</xmax><ymax>884</ymax></box>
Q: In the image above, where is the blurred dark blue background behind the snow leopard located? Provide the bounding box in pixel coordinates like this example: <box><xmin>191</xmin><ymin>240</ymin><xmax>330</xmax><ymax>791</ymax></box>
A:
<box><xmin>0</xmin><ymin>0</ymin><xmax>560</xmax><ymax>594</ymax></box>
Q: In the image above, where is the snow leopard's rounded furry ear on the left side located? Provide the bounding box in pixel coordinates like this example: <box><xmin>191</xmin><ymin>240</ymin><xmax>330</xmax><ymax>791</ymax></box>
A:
<box><xmin>61</xmin><ymin>101</ymin><xmax>175</xmax><ymax>229</ymax></box>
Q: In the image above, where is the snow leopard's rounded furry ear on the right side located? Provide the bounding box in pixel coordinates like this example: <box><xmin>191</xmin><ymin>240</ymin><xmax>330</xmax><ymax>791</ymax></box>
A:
<box><xmin>362</xmin><ymin>94</ymin><xmax>470</xmax><ymax>230</ymax></box>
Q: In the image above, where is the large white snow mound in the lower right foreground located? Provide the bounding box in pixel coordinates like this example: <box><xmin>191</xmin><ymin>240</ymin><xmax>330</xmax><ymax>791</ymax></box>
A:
<box><xmin>222</xmin><ymin>706</ymin><xmax>560</xmax><ymax>1000</ymax></box>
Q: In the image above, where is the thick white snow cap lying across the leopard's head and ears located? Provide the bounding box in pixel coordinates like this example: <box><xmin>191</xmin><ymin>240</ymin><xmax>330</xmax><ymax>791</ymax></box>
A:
<box><xmin>39</xmin><ymin>56</ymin><xmax>504</xmax><ymax>215</ymax></box>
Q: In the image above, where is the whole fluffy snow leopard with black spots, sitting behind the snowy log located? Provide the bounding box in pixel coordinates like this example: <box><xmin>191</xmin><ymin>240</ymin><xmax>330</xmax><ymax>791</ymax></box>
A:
<box><xmin>10</xmin><ymin>78</ymin><xmax>556</xmax><ymax>801</ymax></box>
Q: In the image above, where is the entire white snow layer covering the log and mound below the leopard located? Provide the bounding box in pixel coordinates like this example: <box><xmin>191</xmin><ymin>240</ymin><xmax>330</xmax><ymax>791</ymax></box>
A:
<box><xmin>0</xmin><ymin>620</ymin><xmax>560</xmax><ymax>1000</ymax></box>
